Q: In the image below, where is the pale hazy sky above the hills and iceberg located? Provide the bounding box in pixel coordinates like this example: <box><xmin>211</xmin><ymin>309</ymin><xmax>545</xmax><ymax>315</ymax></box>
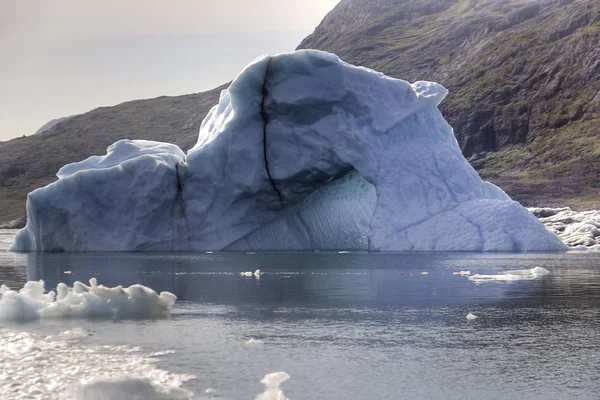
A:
<box><xmin>0</xmin><ymin>0</ymin><xmax>339</xmax><ymax>141</ymax></box>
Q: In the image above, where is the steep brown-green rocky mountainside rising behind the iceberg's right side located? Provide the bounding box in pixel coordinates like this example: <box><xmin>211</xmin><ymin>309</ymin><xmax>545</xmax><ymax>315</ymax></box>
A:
<box><xmin>299</xmin><ymin>0</ymin><xmax>600</xmax><ymax>208</ymax></box>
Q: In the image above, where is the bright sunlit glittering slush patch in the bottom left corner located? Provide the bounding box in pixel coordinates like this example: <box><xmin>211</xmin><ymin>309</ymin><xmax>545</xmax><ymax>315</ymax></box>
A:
<box><xmin>0</xmin><ymin>329</ymin><xmax>195</xmax><ymax>400</ymax></box>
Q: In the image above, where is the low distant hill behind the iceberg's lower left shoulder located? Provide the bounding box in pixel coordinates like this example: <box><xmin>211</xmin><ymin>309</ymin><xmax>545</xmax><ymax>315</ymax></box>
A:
<box><xmin>0</xmin><ymin>87</ymin><xmax>224</xmax><ymax>225</ymax></box>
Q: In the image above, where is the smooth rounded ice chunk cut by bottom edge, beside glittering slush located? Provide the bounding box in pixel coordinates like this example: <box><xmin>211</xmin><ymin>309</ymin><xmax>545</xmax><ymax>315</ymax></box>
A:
<box><xmin>75</xmin><ymin>377</ymin><xmax>191</xmax><ymax>400</ymax></box>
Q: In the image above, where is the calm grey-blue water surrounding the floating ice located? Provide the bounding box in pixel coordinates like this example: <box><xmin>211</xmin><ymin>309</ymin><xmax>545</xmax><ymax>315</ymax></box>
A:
<box><xmin>0</xmin><ymin>228</ymin><xmax>600</xmax><ymax>400</ymax></box>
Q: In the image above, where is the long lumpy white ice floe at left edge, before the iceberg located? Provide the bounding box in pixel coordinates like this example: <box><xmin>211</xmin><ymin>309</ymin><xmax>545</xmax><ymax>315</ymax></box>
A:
<box><xmin>0</xmin><ymin>278</ymin><xmax>177</xmax><ymax>321</ymax></box>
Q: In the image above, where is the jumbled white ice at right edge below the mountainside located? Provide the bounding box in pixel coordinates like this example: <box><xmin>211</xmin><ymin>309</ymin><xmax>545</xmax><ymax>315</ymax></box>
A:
<box><xmin>529</xmin><ymin>207</ymin><xmax>600</xmax><ymax>250</ymax></box>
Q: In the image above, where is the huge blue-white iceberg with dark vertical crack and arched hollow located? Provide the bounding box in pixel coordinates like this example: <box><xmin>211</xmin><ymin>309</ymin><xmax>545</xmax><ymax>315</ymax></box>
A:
<box><xmin>11</xmin><ymin>50</ymin><xmax>565</xmax><ymax>252</ymax></box>
